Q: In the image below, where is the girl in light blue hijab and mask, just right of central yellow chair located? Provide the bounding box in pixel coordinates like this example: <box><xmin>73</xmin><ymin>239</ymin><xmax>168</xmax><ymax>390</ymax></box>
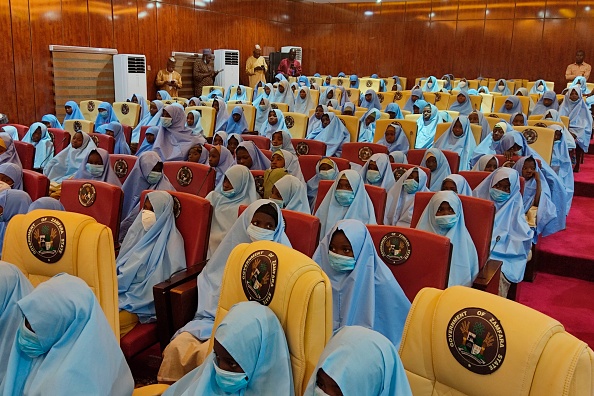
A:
<box><xmin>312</xmin><ymin>219</ymin><xmax>410</xmax><ymax>347</ymax></box>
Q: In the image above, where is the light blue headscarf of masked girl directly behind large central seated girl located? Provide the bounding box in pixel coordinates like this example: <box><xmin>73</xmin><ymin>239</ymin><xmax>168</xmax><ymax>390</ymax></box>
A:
<box><xmin>315</xmin><ymin>169</ymin><xmax>377</xmax><ymax>236</ymax></box>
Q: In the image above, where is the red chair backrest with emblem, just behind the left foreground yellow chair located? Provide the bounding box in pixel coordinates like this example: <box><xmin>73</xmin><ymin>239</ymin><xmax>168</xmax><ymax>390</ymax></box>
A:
<box><xmin>60</xmin><ymin>179</ymin><xmax>124</xmax><ymax>241</ymax></box>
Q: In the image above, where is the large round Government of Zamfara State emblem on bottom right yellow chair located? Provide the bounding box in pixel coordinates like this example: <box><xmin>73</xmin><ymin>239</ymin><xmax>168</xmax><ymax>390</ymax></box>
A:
<box><xmin>446</xmin><ymin>308</ymin><xmax>507</xmax><ymax>375</ymax></box>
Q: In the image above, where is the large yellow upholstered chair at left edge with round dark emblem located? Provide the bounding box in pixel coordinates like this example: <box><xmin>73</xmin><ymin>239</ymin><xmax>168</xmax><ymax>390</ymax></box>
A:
<box><xmin>2</xmin><ymin>210</ymin><xmax>120</xmax><ymax>340</ymax></box>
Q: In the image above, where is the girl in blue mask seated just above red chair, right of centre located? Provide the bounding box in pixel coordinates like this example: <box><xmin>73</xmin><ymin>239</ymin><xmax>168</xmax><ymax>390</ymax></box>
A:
<box><xmin>384</xmin><ymin>168</ymin><xmax>429</xmax><ymax>227</ymax></box>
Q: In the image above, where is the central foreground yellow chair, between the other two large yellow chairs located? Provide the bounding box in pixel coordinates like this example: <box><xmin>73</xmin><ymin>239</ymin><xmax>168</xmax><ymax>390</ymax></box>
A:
<box><xmin>210</xmin><ymin>241</ymin><xmax>332</xmax><ymax>395</ymax></box>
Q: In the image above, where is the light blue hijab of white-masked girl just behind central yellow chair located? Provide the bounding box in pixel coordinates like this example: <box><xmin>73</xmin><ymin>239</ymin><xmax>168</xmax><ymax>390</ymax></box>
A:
<box><xmin>174</xmin><ymin>199</ymin><xmax>292</xmax><ymax>341</ymax></box>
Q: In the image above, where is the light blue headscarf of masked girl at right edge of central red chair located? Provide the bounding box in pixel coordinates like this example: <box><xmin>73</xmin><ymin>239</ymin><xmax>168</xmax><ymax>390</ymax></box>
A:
<box><xmin>416</xmin><ymin>191</ymin><xmax>479</xmax><ymax>287</ymax></box>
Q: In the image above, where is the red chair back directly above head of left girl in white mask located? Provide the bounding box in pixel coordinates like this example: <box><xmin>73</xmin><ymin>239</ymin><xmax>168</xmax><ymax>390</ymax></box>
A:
<box><xmin>163</xmin><ymin>161</ymin><xmax>216</xmax><ymax>197</ymax></box>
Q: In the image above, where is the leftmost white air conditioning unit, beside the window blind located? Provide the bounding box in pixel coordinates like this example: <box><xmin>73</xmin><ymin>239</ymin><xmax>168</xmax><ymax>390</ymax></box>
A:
<box><xmin>113</xmin><ymin>54</ymin><xmax>146</xmax><ymax>102</ymax></box>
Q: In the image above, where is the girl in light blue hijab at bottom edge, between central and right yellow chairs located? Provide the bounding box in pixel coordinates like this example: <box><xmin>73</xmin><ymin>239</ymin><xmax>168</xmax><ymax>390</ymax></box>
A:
<box><xmin>304</xmin><ymin>326</ymin><xmax>412</xmax><ymax>396</ymax></box>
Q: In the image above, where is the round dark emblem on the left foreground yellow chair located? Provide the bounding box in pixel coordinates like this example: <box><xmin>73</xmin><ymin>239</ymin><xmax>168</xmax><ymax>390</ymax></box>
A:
<box><xmin>27</xmin><ymin>216</ymin><xmax>66</xmax><ymax>264</ymax></box>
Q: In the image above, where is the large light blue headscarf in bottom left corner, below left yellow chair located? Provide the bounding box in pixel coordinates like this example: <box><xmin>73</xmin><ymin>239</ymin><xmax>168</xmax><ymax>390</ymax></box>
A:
<box><xmin>0</xmin><ymin>273</ymin><xmax>134</xmax><ymax>396</ymax></box>
